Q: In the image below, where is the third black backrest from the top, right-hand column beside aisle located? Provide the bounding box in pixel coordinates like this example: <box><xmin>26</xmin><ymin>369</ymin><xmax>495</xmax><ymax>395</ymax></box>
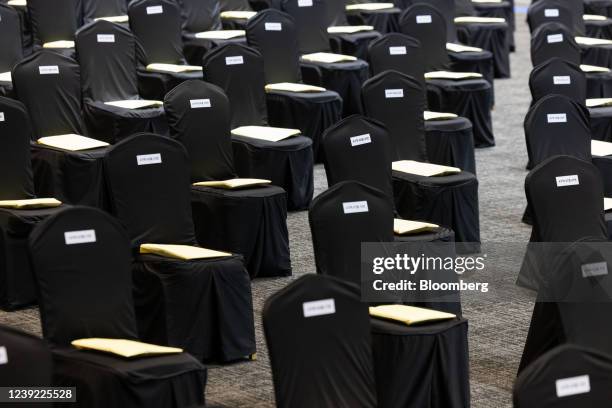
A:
<box><xmin>529</xmin><ymin>58</ymin><xmax>587</xmax><ymax>104</ymax></box>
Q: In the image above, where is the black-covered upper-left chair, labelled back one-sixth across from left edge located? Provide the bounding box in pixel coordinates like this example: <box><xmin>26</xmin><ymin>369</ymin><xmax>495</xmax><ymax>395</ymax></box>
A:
<box><xmin>75</xmin><ymin>20</ymin><xmax>168</xmax><ymax>144</ymax></box>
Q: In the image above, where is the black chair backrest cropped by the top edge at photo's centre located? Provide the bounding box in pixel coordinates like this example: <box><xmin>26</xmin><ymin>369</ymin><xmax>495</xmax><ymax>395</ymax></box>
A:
<box><xmin>281</xmin><ymin>0</ymin><xmax>330</xmax><ymax>54</ymax></box>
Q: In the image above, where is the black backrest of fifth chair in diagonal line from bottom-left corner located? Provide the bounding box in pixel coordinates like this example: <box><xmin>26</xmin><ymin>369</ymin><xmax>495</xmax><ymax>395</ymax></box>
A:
<box><xmin>202</xmin><ymin>43</ymin><xmax>268</xmax><ymax>128</ymax></box>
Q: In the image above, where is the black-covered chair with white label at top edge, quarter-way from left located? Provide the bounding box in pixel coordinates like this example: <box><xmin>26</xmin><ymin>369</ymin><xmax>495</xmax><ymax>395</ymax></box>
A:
<box><xmin>128</xmin><ymin>0</ymin><xmax>202</xmax><ymax>100</ymax></box>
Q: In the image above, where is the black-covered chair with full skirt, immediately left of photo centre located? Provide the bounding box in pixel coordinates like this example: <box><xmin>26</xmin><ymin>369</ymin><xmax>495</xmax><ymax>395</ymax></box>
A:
<box><xmin>164</xmin><ymin>80</ymin><xmax>291</xmax><ymax>277</ymax></box>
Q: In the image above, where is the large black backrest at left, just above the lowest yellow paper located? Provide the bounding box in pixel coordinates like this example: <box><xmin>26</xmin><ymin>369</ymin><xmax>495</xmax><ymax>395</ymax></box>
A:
<box><xmin>29</xmin><ymin>207</ymin><xmax>137</xmax><ymax>346</ymax></box>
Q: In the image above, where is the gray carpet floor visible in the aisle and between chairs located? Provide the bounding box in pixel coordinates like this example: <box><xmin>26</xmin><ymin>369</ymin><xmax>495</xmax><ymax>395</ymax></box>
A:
<box><xmin>0</xmin><ymin>0</ymin><xmax>533</xmax><ymax>408</ymax></box>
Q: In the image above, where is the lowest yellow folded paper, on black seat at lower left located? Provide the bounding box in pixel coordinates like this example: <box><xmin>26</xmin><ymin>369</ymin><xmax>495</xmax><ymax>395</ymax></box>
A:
<box><xmin>70</xmin><ymin>338</ymin><xmax>183</xmax><ymax>358</ymax></box>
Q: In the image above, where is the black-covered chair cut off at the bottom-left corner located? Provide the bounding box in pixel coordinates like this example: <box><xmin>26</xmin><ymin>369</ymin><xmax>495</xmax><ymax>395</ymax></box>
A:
<box><xmin>0</xmin><ymin>325</ymin><xmax>53</xmax><ymax>408</ymax></box>
